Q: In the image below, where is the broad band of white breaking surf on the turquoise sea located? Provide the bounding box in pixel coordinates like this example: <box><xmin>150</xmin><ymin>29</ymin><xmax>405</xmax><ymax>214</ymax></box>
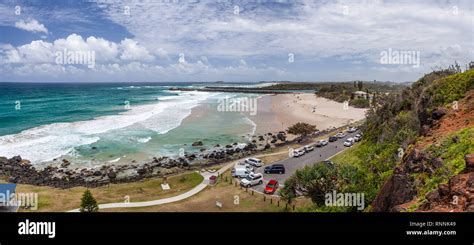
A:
<box><xmin>0</xmin><ymin>92</ymin><xmax>211</xmax><ymax>164</ymax></box>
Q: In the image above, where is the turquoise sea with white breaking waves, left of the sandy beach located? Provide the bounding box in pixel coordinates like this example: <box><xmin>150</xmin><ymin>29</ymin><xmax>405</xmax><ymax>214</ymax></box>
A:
<box><xmin>0</xmin><ymin>83</ymin><xmax>254</xmax><ymax>165</ymax></box>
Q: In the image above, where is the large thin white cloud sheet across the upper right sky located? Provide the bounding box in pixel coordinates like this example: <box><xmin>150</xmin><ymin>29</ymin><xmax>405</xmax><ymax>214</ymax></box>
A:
<box><xmin>96</xmin><ymin>0</ymin><xmax>473</xmax><ymax>74</ymax></box>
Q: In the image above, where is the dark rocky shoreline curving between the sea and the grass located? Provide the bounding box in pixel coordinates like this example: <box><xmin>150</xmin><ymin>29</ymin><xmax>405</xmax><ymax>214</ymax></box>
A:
<box><xmin>0</xmin><ymin>125</ymin><xmax>337</xmax><ymax>189</ymax></box>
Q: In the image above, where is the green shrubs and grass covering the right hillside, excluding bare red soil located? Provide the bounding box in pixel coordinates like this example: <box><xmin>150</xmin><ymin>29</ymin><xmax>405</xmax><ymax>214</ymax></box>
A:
<box><xmin>288</xmin><ymin>65</ymin><xmax>474</xmax><ymax>211</ymax></box>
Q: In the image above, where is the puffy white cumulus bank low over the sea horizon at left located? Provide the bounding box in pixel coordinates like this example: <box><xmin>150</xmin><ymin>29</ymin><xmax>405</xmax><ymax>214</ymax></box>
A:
<box><xmin>0</xmin><ymin>31</ymin><xmax>284</xmax><ymax>81</ymax></box>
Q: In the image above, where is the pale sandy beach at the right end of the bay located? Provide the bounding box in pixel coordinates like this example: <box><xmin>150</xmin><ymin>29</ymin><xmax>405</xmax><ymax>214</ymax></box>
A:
<box><xmin>250</xmin><ymin>93</ymin><xmax>366</xmax><ymax>134</ymax></box>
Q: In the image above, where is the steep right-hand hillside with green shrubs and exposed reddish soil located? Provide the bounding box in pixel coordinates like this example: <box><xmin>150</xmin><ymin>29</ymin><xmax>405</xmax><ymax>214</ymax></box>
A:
<box><xmin>284</xmin><ymin>62</ymin><xmax>474</xmax><ymax>211</ymax></box>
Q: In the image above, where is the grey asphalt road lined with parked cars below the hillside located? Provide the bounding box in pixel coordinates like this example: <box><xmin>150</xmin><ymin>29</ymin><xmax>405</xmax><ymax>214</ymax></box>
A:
<box><xmin>248</xmin><ymin>132</ymin><xmax>358</xmax><ymax>192</ymax></box>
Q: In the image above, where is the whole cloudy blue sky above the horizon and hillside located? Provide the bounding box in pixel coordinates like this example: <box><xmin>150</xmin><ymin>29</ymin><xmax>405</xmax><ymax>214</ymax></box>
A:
<box><xmin>0</xmin><ymin>0</ymin><xmax>474</xmax><ymax>82</ymax></box>
